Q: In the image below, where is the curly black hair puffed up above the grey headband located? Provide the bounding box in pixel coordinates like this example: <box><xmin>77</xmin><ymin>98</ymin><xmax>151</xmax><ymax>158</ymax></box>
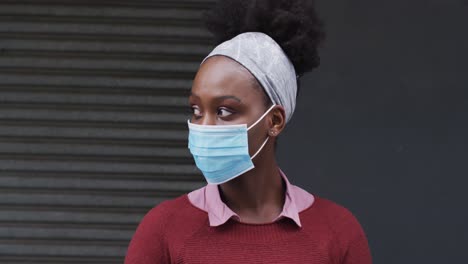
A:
<box><xmin>204</xmin><ymin>0</ymin><xmax>325</xmax><ymax>76</ymax></box>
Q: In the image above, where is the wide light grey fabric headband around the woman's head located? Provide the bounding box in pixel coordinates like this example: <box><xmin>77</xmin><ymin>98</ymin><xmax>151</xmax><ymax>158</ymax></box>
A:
<box><xmin>202</xmin><ymin>32</ymin><xmax>297</xmax><ymax>122</ymax></box>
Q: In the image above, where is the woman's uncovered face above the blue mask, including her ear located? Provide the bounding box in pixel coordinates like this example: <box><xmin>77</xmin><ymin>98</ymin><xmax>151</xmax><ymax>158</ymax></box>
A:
<box><xmin>189</xmin><ymin>56</ymin><xmax>272</xmax><ymax>155</ymax></box>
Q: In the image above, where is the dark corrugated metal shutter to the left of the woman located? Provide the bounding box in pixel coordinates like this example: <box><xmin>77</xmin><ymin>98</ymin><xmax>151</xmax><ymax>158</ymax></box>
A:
<box><xmin>0</xmin><ymin>0</ymin><xmax>211</xmax><ymax>263</ymax></box>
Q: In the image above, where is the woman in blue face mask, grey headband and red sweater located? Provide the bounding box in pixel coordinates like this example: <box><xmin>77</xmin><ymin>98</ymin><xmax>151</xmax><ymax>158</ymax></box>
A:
<box><xmin>125</xmin><ymin>0</ymin><xmax>371</xmax><ymax>264</ymax></box>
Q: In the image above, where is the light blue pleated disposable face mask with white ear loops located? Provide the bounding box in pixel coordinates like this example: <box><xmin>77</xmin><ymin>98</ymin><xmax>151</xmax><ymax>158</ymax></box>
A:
<box><xmin>187</xmin><ymin>105</ymin><xmax>275</xmax><ymax>184</ymax></box>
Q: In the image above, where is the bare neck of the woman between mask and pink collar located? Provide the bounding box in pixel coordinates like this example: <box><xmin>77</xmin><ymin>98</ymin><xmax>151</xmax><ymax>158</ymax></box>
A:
<box><xmin>219</xmin><ymin>156</ymin><xmax>285</xmax><ymax>223</ymax></box>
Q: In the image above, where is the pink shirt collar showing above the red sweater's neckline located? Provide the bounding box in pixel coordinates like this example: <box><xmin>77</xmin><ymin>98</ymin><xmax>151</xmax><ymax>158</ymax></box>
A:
<box><xmin>188</xmin><ymin>169</ymin><xmax>315</xmax><ymax>227</ymax></box>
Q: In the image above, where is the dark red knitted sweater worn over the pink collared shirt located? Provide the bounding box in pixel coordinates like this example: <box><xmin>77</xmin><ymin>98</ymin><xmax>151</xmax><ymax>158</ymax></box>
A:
<box><xmin>125</xmin><ymin>195</ymin><xmax>371</xmax><ymax>264</ymax></box>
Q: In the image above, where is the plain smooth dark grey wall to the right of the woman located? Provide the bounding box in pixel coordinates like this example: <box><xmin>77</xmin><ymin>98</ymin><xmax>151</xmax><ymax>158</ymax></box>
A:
<box><xmin>278</xmin><ymin>0</ymin><xmax>468</xmax><ymax>264</ymax></box>
